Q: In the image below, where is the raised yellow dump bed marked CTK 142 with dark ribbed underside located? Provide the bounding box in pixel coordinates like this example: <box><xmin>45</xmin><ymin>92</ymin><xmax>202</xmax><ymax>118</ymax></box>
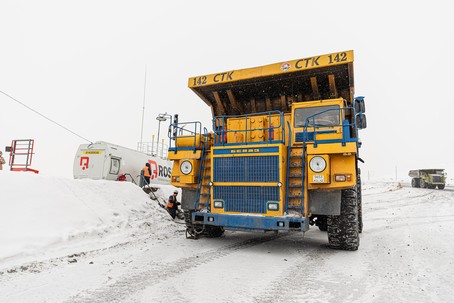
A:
<box><xmin>188</xmin><ymin>50</ymin><xmax>354</xmax><ymax>116</ymax></box>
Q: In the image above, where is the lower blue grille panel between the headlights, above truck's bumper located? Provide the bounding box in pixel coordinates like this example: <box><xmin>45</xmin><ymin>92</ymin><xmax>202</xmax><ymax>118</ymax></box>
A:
<box><xmin>213</xmin><ymin>186</ymin><xmax>279</xmax><ymax>214</ymax></box>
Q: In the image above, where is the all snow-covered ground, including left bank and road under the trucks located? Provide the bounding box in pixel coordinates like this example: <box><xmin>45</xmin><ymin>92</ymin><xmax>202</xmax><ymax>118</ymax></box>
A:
<box><xmin>0</xmin><ymin>171</ymin><xmax>454</xmax><ymax>302</ymax></box>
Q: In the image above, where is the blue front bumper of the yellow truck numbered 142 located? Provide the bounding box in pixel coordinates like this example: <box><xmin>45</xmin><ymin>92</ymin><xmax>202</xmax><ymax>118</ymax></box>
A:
<box><xmin>192</xmin><ymin>212</ymin><xmax>309</xmax><ymax>232</ymax></box>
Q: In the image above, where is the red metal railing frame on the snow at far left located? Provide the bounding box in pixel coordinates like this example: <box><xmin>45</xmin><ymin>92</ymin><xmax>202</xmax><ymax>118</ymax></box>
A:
<box><xmin>9</xmin><ymin>139</ymin><xmax>39</xmax><ymax>174</ymax></box>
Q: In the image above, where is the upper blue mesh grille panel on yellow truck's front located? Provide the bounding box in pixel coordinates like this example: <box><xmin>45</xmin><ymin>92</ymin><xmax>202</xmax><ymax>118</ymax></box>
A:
<box><xmin>213</xmin><ymin>156</ymin><xmax>279</xmax><ymax>182</ymax></box>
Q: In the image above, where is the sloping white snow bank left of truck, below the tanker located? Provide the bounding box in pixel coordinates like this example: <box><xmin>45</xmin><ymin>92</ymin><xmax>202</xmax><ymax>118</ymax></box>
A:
<box><xmin>0</xmin><ymin>171</ymin><xmax>179</xmax><ymax>264</ymax></box>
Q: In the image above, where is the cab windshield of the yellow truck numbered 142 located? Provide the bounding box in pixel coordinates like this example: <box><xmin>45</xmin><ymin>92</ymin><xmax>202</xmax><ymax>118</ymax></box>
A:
<box><xmin>294</xmin><ymin>105</ymin><xmax>340</xmax><ymax>127</ymax></box>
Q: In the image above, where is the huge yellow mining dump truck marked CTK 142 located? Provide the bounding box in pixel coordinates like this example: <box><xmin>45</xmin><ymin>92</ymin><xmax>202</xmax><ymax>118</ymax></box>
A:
<box><xmin>169</xmin><ymin>51</ymin><xmax>366</xmax><ymax>250</ymax></box>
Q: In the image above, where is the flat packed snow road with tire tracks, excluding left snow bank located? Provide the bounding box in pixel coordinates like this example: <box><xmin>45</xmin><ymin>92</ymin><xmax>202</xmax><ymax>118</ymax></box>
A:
<box><xmin>0</xmin><ymin>175</ymin><xmax>454</xmax><ymax>302</ymax></box>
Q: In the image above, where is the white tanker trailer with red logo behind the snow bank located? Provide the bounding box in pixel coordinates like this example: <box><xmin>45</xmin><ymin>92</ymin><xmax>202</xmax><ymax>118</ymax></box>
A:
<box><xmin>73</xmin><ymin>141</ymin><xmax>173</xmax><ymax>185</ymax></box>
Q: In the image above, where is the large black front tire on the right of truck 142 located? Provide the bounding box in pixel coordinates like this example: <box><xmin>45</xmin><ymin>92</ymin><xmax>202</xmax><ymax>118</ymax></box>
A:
<box><xmin>327</xmin><ymin>189</ymin><xmax>359</xmax><ymax>250</ymax></box>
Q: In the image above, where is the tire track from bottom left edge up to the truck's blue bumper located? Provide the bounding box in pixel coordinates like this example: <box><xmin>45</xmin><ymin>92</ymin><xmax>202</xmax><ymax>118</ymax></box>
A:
<box><xmin>65</xmin><ymin>234</ymin><xmax>288</xmax><ymax>303</ymax></box>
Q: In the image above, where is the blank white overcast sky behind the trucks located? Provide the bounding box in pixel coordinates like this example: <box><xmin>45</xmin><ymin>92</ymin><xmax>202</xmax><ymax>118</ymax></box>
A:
<box><xmin>0</xmin><ymin>0</ymin><xmax>454</xmax><ymax>180</ymax></box>
